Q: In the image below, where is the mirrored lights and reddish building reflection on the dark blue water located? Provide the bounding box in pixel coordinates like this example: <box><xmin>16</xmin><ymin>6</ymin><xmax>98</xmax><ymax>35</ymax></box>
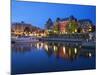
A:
<box><xmin>12</xmin><ymin>42</ymin><xmax>94</xmax><ymax>59</ymax></box>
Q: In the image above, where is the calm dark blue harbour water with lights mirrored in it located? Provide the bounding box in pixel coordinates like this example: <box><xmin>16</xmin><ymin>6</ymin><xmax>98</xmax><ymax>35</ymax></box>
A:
<box><xmin>11</xmin><ymin>41</ymin><xmax>96</xmax><ymax>74</ymax></box>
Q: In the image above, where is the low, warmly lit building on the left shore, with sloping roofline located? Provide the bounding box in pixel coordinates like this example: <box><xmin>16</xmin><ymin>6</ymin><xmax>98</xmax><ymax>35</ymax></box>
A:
<box><xmin>11</xmin><ymin>22</ymin><xmax>43</xmax><ymax>36</ymax></box>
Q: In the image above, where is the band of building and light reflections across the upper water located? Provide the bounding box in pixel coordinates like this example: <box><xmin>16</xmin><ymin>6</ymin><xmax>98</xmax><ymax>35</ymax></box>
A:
<box><xmin>12</xmin><ymin>42</ymin><xmax>95</xmax><ymax>60</ymax></box>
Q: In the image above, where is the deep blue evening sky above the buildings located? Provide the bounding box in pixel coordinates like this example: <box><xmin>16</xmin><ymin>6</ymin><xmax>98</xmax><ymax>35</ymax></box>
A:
<box><xmin>12</xmin><ymin>0</ymin><xmax>96</xmax><ymax>28</ymax></box>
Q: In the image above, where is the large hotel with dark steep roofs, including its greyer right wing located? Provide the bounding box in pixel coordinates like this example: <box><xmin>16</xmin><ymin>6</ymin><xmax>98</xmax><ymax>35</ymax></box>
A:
<box><xmin>54</xmin><ymin>16</ymin><xmax>93</xmax><ymax>34</ymax></box>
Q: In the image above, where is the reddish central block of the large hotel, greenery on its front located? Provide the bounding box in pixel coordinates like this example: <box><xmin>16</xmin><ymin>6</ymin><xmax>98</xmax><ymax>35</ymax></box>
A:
<box><xmin>54</xmin><ymin>16</ymin><xmax>78</xmax><ymax>33</ymax></box>
